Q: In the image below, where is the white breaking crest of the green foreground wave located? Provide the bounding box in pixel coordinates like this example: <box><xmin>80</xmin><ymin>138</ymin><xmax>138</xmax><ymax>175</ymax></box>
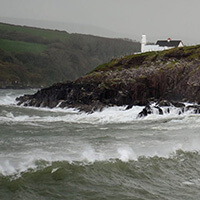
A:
<box><xmin>0</xmin><ymin>144</ymin><xmax>200</xmax><ymax>178</ymax></box>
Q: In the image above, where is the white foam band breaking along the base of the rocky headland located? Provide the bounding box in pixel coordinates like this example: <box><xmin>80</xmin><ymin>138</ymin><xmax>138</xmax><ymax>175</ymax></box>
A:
<box><xmin>0</xmin><ymin>106</ymin><xmax>200</xmax><ymax>126</ymax></box>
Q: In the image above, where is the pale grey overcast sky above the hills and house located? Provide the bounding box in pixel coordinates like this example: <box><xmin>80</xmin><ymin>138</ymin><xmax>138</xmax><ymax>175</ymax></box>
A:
<box><xmin>0</xmin><ymin>0</ymin><xmax>200</xmax><ymax>44</ymax></box>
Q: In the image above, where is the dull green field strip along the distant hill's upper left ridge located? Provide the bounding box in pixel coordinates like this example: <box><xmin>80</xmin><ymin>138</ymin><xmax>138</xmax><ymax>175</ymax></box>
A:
<box><xmin>0</xmin><ymin>23</ymin><xmax>70</xmax><ymax>41</ymax></box>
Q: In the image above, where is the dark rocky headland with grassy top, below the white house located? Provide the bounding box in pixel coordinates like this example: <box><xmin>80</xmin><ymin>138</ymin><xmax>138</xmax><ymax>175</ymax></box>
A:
<box><xmin>18</xmin><ymin>46</ymin><xmax>200</xmax><ymax>111</ymax></box>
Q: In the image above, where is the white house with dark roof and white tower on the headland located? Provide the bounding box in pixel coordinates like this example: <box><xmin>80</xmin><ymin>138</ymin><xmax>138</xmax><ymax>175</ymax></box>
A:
<box><xmin>141</xmin><ymin>35</ymin><xmax>184</xmax><ymax>53</ymax></box>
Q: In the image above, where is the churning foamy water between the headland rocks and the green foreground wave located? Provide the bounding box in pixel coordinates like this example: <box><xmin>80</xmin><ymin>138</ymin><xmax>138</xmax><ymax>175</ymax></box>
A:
<box><xmin>0</xmin><ymin>92</ymin><xmax>200</xmax><ymax>182</ymax></box>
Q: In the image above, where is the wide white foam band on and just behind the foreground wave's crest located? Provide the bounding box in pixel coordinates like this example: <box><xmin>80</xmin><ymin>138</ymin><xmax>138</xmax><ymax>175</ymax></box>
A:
<box><xmin>0</xmin><ymin>138</ymin><xmax>200</xmax><ymax>176</ymax></box>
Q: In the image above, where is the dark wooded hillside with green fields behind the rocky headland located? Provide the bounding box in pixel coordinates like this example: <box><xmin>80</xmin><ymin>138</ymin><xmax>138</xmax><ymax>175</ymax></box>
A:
<box><xmin>0</xmin><ymin>23</ymin><xmax>140</xmax><ymax>88</ymax></box>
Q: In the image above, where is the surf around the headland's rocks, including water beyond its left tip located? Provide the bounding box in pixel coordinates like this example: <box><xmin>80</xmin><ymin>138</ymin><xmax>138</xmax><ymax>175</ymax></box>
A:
<box><xmin>0</xmin><ymin>90</ymin><xmax>198</xmax><ymax>124</ymax></box>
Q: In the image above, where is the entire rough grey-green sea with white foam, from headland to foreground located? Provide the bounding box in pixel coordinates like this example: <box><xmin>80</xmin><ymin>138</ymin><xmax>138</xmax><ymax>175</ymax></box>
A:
<box><xmin>0</xmin><ymin>89</ymin><xmax>200</xmax><ymax>200</ymax></box>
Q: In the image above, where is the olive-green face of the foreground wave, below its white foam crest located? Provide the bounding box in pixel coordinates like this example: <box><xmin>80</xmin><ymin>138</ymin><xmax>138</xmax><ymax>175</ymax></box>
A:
<box><xmin>0</xmin><ymin>151</ymin><xmax>200</xmax><ymax>200</ymax></box>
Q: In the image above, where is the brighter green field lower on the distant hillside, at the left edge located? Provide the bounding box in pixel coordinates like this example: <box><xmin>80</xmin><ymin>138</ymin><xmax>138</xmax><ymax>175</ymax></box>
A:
<box><xmin>0</xmin><ymin>39</ymin><xmax>47</xmax><ymax>54</ymax></box>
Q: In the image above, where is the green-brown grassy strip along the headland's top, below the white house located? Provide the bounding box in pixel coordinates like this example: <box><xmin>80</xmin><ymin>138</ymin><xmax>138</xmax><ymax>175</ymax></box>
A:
<box><xmin>91</xmin><ymin>45</ymin><xmax>200</xmax><ymax>73</ymax></box>
